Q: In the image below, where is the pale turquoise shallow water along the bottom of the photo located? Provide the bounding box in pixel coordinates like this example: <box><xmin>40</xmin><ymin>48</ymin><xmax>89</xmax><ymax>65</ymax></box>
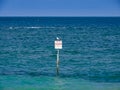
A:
<box><xmin>0</xmin><ymin>75</ymin><xmax>120</xmax><ymax>90</ymax></box>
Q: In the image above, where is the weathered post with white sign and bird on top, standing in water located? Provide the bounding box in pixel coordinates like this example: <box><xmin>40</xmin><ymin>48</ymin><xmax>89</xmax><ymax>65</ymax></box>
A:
<box><xmin>55</xmin><ymin>37</ymin><xmax>62</xmax><ymax>75</ymax></box>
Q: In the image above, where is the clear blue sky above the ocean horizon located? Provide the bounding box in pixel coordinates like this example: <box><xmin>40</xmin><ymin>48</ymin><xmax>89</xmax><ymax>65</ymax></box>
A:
<box><xmin>0</xmin><ymin>0</ymin><xmax>120</xmax><ymax>16</ymax></box>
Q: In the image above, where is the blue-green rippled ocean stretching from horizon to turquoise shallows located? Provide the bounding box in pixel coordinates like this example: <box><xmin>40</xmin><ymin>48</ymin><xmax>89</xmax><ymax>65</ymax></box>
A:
<box><xmin>0</xmin><ymin>17</ymin><xmax>120</xmax><ymax>90</ymax></box>
